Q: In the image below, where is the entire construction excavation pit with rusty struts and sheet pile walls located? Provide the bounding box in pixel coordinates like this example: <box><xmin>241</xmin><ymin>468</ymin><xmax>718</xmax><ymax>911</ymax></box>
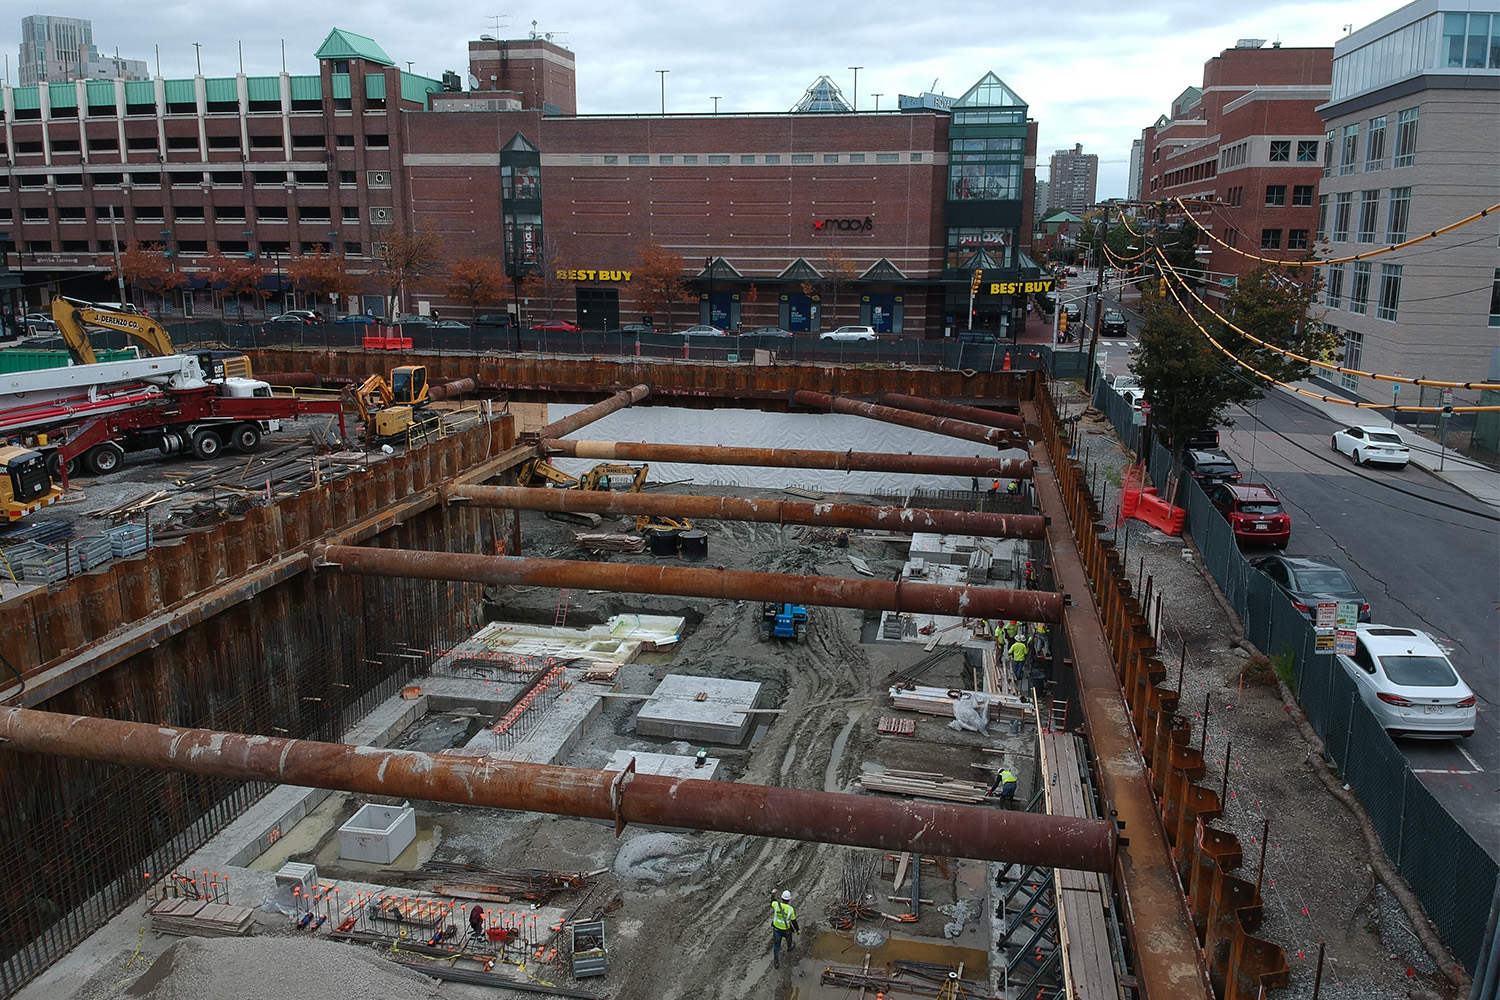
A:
<box><xmin>0</xmin><ymin>373</ymin><xmax>1314</xmax><ymax>1000</ymax></box>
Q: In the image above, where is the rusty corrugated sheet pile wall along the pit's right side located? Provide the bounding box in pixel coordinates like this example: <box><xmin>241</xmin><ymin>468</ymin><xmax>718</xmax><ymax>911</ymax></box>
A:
<box><xmin>1038</xmin><ymin>385</ymin><xmax>1290</xmax><ymax>1000</ymax></box>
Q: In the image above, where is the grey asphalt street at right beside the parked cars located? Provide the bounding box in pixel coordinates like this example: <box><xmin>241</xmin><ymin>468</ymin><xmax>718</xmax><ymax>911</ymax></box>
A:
<box><xmin>1221</xmin><ymin>393</ymin><xmax>1500</xmax><ymax>859</ymax></box>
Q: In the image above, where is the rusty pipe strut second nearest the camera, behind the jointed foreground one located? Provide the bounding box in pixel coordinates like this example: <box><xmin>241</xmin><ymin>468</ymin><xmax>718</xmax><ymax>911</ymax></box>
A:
<box><xmin>312</xmin><ymin>546</ymin><xmax>1062</xmax><ymax>622</ymax></box>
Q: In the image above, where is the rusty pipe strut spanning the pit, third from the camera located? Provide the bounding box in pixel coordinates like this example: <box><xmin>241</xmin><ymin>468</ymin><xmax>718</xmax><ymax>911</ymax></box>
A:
<box><xmin>443</xmin><ymin>486</ymin><xmax>1047</xmax><ymax>538</ymax></box>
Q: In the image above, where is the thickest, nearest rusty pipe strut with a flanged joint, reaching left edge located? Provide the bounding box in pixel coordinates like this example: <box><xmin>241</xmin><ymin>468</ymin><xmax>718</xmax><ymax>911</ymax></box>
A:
<box><xmin>0</xmin><ymin>708</ymin><xmax>1118</xmax><ymax>871</ymax></box>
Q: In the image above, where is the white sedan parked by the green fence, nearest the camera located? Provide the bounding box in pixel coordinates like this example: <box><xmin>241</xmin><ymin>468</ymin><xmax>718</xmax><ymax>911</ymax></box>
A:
<box><xmin>1338</xmin><ymin>624</ymin><xmax>1476</xmax><ymax>739</ymax></box>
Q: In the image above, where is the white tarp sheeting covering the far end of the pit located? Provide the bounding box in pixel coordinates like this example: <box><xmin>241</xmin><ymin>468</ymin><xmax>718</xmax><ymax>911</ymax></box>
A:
<box><xmin>548</xmin><ymin>403</ymin><xmax>1026</xmax><ymax>493</ymax></box>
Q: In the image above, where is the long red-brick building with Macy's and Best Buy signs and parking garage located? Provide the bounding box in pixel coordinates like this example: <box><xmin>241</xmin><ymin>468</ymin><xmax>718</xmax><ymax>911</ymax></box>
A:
<box><xmin>0</xmin><ymin>30</ymin><xmax>1040</xmax><ymax>336</ymax></box>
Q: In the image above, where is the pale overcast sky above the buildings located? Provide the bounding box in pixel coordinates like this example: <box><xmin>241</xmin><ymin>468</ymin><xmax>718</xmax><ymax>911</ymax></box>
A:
<box><xmin>0</xmin><ymin>0</ymin><xmax>1401</xmax><ymax>198</ymax></box>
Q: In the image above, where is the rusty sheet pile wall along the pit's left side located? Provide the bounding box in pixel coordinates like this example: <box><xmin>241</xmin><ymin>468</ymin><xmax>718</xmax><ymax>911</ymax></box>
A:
<box><xmin>0</xmin><ymin>426</ymin><xmax>498</xmax><ymax>996</ymax></box>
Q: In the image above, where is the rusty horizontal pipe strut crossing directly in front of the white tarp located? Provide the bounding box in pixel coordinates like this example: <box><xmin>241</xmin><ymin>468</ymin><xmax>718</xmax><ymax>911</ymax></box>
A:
<box><xmin>542</xmin><ymin>438</ymin><xmax>1032</xmax><ymax>480</ymax></box>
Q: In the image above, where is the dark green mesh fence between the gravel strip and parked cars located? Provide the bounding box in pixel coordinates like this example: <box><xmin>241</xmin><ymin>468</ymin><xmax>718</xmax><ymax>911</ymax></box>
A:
<box><xmin>1151</xmin><ymin>410</ymin><xmax>1500</xmax><ymax>972</ymax></box>
